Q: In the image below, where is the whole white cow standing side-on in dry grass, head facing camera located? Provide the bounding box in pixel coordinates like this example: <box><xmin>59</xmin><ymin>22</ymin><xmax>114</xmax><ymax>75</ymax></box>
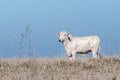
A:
<box><xmin>57</xmin><ymin>31</ymin><xmax>100</xmax><ymax>60</ymax></box>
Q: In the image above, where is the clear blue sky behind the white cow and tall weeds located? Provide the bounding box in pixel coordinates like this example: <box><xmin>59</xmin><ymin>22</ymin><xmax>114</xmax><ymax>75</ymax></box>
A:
<box><xmin>0</xmin><ymin>0</ymin><xmax>120</xmax><ymax>57</ymax></box>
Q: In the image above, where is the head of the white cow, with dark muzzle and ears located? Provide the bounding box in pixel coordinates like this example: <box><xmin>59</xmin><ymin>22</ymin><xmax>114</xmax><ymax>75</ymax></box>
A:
<box><xmin>57</xmin><ymin>31</ymin><xmax>71</xmax><ymax>43</ymax></box>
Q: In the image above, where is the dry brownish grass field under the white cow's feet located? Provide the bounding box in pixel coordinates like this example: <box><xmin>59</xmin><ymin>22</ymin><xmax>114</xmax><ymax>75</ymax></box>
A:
<box><xmin>0</xmin><ymin>58</ymin><xmax>120</xmax><ymax>80</ymax></box>
